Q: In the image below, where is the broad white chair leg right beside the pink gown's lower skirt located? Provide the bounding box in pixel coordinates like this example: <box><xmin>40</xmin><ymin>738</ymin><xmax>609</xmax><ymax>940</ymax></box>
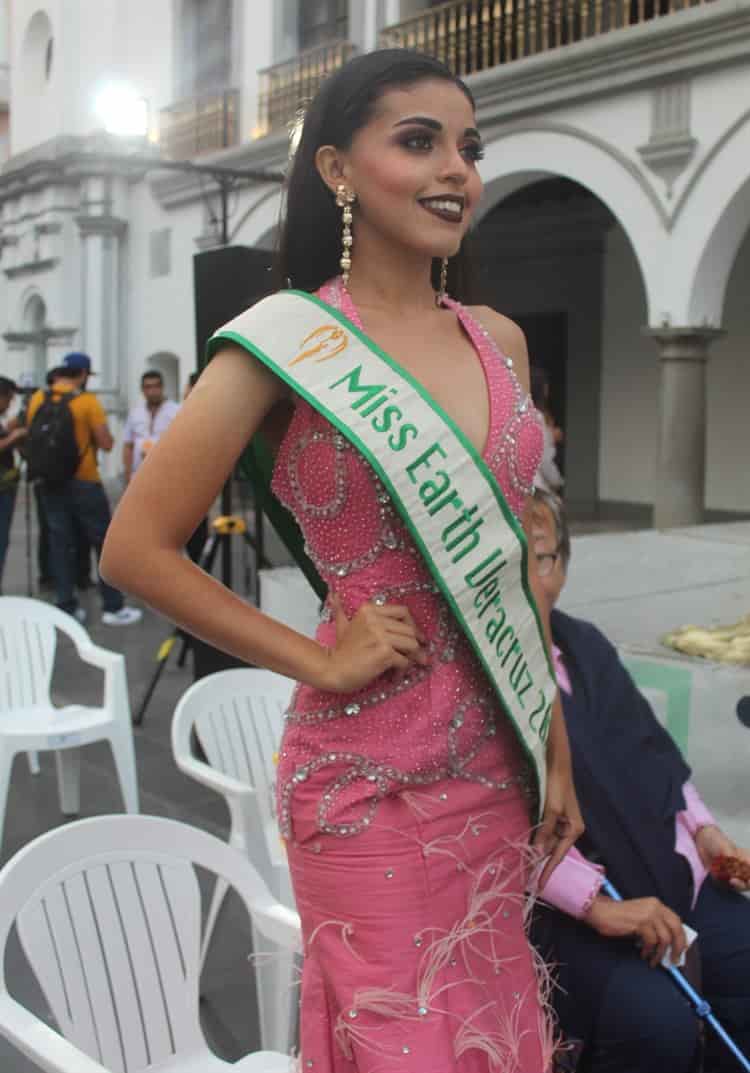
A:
<box><xmin>252</xmin><ymin>927</ymin><xmax>299</xmax><ymax>1055</ymax></box>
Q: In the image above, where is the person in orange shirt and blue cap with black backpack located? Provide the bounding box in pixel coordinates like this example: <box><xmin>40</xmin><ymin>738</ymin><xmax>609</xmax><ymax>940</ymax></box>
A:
<box><xmin>26</xmin><ymin>351</ymin><xmax>142</xmax><ymax>626</ymax></box>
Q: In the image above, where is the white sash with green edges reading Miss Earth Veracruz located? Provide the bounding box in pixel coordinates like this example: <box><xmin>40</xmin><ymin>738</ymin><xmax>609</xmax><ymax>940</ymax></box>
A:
<box><xmin>209</xmin><ymin>291</ymin><xmax>556</xmax><ymax>813</ymax></box>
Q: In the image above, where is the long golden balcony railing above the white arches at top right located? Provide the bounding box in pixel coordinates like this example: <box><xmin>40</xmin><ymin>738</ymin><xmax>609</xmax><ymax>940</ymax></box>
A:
<box><xmin>380</xmin><ymin>0</ymin><xmax>707</xmax><ymax>77</ymax></box>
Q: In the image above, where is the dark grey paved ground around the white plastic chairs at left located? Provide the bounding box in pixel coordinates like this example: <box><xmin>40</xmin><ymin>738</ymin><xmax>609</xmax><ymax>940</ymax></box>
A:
<box><xmin>0</xmin><ymin>490</ymin><xmax>268</xmax><ymax>1073</ymax></box>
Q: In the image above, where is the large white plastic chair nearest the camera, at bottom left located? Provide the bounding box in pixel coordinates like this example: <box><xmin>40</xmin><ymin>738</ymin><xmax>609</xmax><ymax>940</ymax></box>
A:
<box><xmin>0</xmin><ymin>815</ymin><xmax>299</xmax><ymax>1073</ymax></box>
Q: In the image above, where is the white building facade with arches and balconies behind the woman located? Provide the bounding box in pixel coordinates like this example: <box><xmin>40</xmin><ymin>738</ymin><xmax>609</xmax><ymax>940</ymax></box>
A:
<box><xmin>0</xmin><ymin>0</ymin><xmax>750</xmax><ymax>526</ymax></box>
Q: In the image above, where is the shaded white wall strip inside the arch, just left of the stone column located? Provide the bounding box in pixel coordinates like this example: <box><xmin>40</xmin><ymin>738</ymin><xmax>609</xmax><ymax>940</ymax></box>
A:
<box><xmin>599</xmin><ymin>226</ymin><xmax>659</xmax><ymax>503</ymax></box>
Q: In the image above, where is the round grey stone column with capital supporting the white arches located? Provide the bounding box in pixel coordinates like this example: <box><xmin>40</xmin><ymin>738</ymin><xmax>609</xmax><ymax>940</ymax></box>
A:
<box><xmin>646</xmin><ymin>327</ymin><xmax>724</xmax><ymax>529</ymax></box>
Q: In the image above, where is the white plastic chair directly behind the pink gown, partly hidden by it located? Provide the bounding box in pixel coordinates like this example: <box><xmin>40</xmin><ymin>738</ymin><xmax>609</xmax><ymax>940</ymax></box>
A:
<box><xmin>172</xmin><ymin>667</ymin><xmax>296</xmax><ymax>1050</ymax></box>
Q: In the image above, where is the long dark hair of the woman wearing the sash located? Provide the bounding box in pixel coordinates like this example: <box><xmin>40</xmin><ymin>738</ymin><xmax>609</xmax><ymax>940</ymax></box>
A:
<box><xmin>276</xmin><ymin>48</ymin><xmax>474</xmax><ymax>302</ymax></box>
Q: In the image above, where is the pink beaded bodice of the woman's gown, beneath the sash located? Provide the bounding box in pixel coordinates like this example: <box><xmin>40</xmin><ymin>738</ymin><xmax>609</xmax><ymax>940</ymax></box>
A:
<box><xmin>273</xmin><ymin>280</ymin><xmax>543</xmax><ymax>838</ymax></box>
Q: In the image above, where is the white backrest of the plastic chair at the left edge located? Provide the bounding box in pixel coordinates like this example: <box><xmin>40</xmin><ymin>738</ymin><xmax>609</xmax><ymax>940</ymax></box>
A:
<box><xmin>0</xmin><ymin>597</ymin><xmax>65</xmax><ymax>714</ymax></box>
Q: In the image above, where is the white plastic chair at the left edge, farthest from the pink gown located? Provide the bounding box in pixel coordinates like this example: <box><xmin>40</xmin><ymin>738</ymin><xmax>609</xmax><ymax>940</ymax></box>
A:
<box><xmin>0</xmin><ymin>597</ymin><xmax>138</xmax><ymax>842</ymax></box>
